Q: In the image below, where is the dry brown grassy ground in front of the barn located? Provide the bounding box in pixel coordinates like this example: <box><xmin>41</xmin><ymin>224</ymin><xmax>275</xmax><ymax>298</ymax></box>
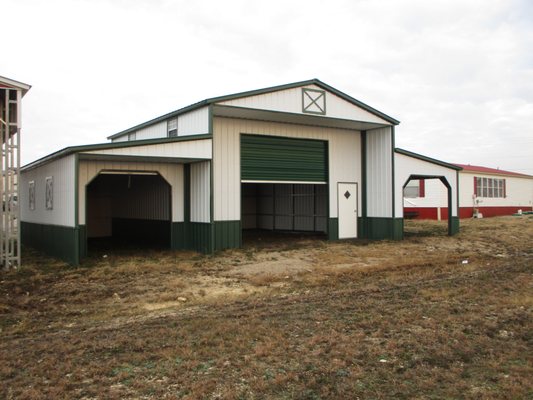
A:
<box><xmin>0</xmin><ymin>215</ymin><xmax>533</xmax><ymax>399</ymax></box>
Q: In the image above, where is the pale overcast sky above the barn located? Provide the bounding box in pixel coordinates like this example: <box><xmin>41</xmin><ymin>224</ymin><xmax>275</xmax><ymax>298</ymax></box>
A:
<box><xmin>4</xmin><ymin>0</ymin><xmax>533</xmax><ymax>174</ymax></box>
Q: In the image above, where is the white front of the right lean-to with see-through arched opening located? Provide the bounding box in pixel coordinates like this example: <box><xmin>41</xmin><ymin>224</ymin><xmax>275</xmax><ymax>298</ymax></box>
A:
<box><xmin>394</xmin><ymin>149</ymin><xmax>461</xmax><ymax>235</ymax></box>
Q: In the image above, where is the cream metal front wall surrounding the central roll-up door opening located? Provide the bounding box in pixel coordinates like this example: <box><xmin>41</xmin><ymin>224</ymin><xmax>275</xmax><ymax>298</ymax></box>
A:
<box><xmin>213</xmin><ymin>118</ymin><xmax>361</xmax><ymax>221</ymax></box>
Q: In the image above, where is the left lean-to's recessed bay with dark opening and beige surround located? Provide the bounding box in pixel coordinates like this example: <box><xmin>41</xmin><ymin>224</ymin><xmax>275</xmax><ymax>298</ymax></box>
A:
<box><xmin>78</xmin><ymin>154</ymin><xmax>184</xmax><ymax>257</ymax></box>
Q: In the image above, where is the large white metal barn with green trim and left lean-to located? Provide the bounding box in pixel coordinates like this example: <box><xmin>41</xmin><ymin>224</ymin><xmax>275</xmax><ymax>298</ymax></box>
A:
<box><xmin>21</xmin><ymin>79</ymin><xmax>457</xmax><ymax>264</ymax></box>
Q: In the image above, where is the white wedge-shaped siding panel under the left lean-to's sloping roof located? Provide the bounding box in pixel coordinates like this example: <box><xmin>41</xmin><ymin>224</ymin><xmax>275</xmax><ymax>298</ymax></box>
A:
<box><xmin>84</xmin><ymin>139</ymin><xmax>212</xmax><ymax>159</ymax></box>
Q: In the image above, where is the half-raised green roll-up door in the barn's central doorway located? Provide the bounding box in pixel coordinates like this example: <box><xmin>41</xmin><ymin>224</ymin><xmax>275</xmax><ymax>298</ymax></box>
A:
<box><xmin>241</xmin><ymin>134</ymin><xmax>328</xmax><ymax>183</ymax></box>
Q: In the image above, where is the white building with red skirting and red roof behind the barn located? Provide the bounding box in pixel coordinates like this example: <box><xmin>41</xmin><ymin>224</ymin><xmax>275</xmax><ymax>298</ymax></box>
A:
<box><xmin>404</xmin><ymin>164</ymin><xmax>533</xmax><ymax>220</ymax></box>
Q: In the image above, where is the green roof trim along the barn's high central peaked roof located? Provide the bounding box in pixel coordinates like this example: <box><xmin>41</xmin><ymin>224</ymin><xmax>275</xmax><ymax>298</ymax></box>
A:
<box><xmin>108</xmin><ymin>79</ymin><xmax>400</xmax><ymax>139</ymax></box>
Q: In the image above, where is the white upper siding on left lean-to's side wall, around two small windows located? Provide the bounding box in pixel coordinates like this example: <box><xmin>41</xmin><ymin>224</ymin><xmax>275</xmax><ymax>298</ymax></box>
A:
<box><xmin>19</xmin><ymin>155</ymin><xmax>75</xmax><ymax>227</ymax></box>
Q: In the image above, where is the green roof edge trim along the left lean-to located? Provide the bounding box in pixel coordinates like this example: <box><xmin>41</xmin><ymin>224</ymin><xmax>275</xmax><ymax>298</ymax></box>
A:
<box><xmin>21</xmin><ymin>134</ymin><xmax>213</xmax><ymax>171</ymax></box>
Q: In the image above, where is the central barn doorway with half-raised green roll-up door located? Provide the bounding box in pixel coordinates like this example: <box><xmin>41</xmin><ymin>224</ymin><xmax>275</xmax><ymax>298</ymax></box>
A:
<box><xmin>241</xmin><ymin>134</ymin><xmax>329</xmax><ymax>241</ymax></box>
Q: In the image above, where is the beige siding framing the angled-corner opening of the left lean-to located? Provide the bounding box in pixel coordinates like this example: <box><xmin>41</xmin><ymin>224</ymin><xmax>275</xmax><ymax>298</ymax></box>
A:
<box><xmin>78</xmin><ymin>160</ymin><xmax>184</xmax><ymax>225</ymax></box>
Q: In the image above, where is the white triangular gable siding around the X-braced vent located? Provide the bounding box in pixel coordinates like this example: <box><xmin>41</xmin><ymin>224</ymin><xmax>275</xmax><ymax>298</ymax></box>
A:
<box><xmin>217</xmin><ymin>85</ymin><xmax>390</xmax><ymax>125</ymax></box>
